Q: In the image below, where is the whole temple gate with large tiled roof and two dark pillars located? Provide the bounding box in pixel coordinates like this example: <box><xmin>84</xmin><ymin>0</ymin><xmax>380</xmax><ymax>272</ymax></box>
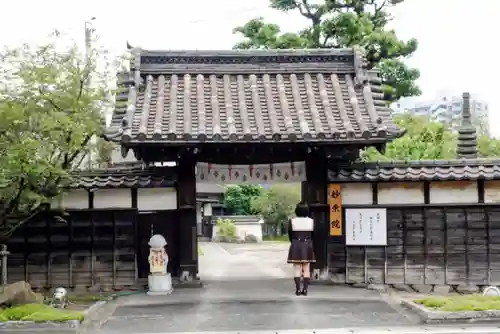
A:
<box><xmin>106</xmin><ymin>48</ymin><xmax>403</xmax><ymax>280</ymax></box>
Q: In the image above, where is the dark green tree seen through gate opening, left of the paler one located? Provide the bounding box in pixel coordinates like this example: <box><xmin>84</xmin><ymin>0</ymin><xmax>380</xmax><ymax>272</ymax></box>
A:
<box><xmin>224</xmin><ymin>184</ymin><xmax>264</xmax><ymax>215</ymax></box>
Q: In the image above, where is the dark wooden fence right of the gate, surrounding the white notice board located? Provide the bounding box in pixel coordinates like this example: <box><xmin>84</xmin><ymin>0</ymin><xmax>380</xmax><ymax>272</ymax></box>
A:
<box><xmin>327</xmin><ymin>204</ymin><xmax>500</xmax><ymax>285</ymax></box>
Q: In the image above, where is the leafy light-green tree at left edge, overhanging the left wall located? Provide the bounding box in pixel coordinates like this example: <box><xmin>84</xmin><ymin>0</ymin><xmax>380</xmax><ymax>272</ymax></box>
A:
<box><xmin>0</xmin><ymin>32</ymin><xmax>118</xmax><ymax>243</ymax></box>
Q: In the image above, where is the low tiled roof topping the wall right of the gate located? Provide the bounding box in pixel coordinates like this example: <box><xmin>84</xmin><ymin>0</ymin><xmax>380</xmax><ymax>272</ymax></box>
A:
<box><xmin>328</xmin><ymin>159</ymin><xmax>500</xmax><ymax>182</ymax></box>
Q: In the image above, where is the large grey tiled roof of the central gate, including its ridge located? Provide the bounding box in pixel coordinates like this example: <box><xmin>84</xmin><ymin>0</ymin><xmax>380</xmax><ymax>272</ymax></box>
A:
<box><xmin>107</xmin><ymin>49</ymin><xmax>402</xmax><ymax>143</ymax></box>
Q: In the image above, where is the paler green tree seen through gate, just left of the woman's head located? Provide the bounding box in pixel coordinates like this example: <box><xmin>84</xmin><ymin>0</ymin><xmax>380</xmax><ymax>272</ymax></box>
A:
<box><xmin>252</xmin><ymin>184</ymin><xmax>300</xmax><ymax>232</ymax></box>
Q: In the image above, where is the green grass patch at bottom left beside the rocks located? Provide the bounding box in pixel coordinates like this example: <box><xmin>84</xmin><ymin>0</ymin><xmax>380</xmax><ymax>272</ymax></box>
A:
<box><xmin>0</xmin><ymin>304</ymin><xmax>84</xmax><ymax>322</ymax></box>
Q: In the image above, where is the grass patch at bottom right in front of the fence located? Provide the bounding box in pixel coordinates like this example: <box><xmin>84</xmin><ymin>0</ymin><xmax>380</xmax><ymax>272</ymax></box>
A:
<box><xmin>414</xmin><ymin>295</ymin><xmax>500</xmax><ymax>312</ymax></box>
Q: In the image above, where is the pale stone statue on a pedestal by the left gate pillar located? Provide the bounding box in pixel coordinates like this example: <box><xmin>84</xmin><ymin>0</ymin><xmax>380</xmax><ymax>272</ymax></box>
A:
<box><xmin>148</xmin><ymin>234</ymin><xmax>172</xmax><ymax>295</ymax></box>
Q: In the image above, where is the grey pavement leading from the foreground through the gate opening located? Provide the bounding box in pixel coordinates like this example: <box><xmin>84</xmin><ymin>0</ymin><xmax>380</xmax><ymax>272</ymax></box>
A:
<box><xmin>89</xmin><ymin>243</ymin><xmax>416</xmax><ymax>334</ymax></box>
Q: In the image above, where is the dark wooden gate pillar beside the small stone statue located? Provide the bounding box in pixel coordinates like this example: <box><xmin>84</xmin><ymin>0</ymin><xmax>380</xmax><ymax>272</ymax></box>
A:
<box><xmin>177</xmin><ymin>156</ymin><xmax>198</xmax><ymax>282</ymax></box>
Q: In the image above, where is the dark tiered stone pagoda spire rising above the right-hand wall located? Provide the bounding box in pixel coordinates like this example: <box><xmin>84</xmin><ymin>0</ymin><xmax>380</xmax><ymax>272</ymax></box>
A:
<box><xmin>457</xmin><ymin>92</ymin><xmax>477</xmax><ymax>159</ymax></box>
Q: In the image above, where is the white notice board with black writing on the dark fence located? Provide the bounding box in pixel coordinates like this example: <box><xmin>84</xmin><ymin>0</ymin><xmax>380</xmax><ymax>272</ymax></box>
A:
<box><xmin>345</xmin><ymin>209</ymin><xmax>387</xmax><ymax>246</ymax></box>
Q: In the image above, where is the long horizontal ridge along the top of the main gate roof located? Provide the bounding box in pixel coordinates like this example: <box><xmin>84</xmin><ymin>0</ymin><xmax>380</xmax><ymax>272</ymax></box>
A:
<box><xmin>137</xmin><ymin>48</ymin><xmax>354</xmax><ymax>75</ymax></box>
